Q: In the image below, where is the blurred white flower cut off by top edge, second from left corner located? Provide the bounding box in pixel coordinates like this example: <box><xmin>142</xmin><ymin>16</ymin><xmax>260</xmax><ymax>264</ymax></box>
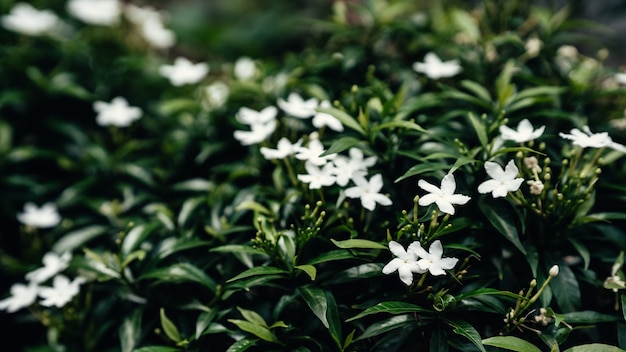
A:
<box><xmin>67</xmin><ymin>0</ymin><xmax>122</xmax><ymax>26</ymax></box>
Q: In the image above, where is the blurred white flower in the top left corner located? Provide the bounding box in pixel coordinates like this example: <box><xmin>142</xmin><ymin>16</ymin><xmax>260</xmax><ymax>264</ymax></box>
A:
<box><xmin>1</xmin><ymin>2</ymin><xmax>61</xmax><ymax>35</ymax></box>
